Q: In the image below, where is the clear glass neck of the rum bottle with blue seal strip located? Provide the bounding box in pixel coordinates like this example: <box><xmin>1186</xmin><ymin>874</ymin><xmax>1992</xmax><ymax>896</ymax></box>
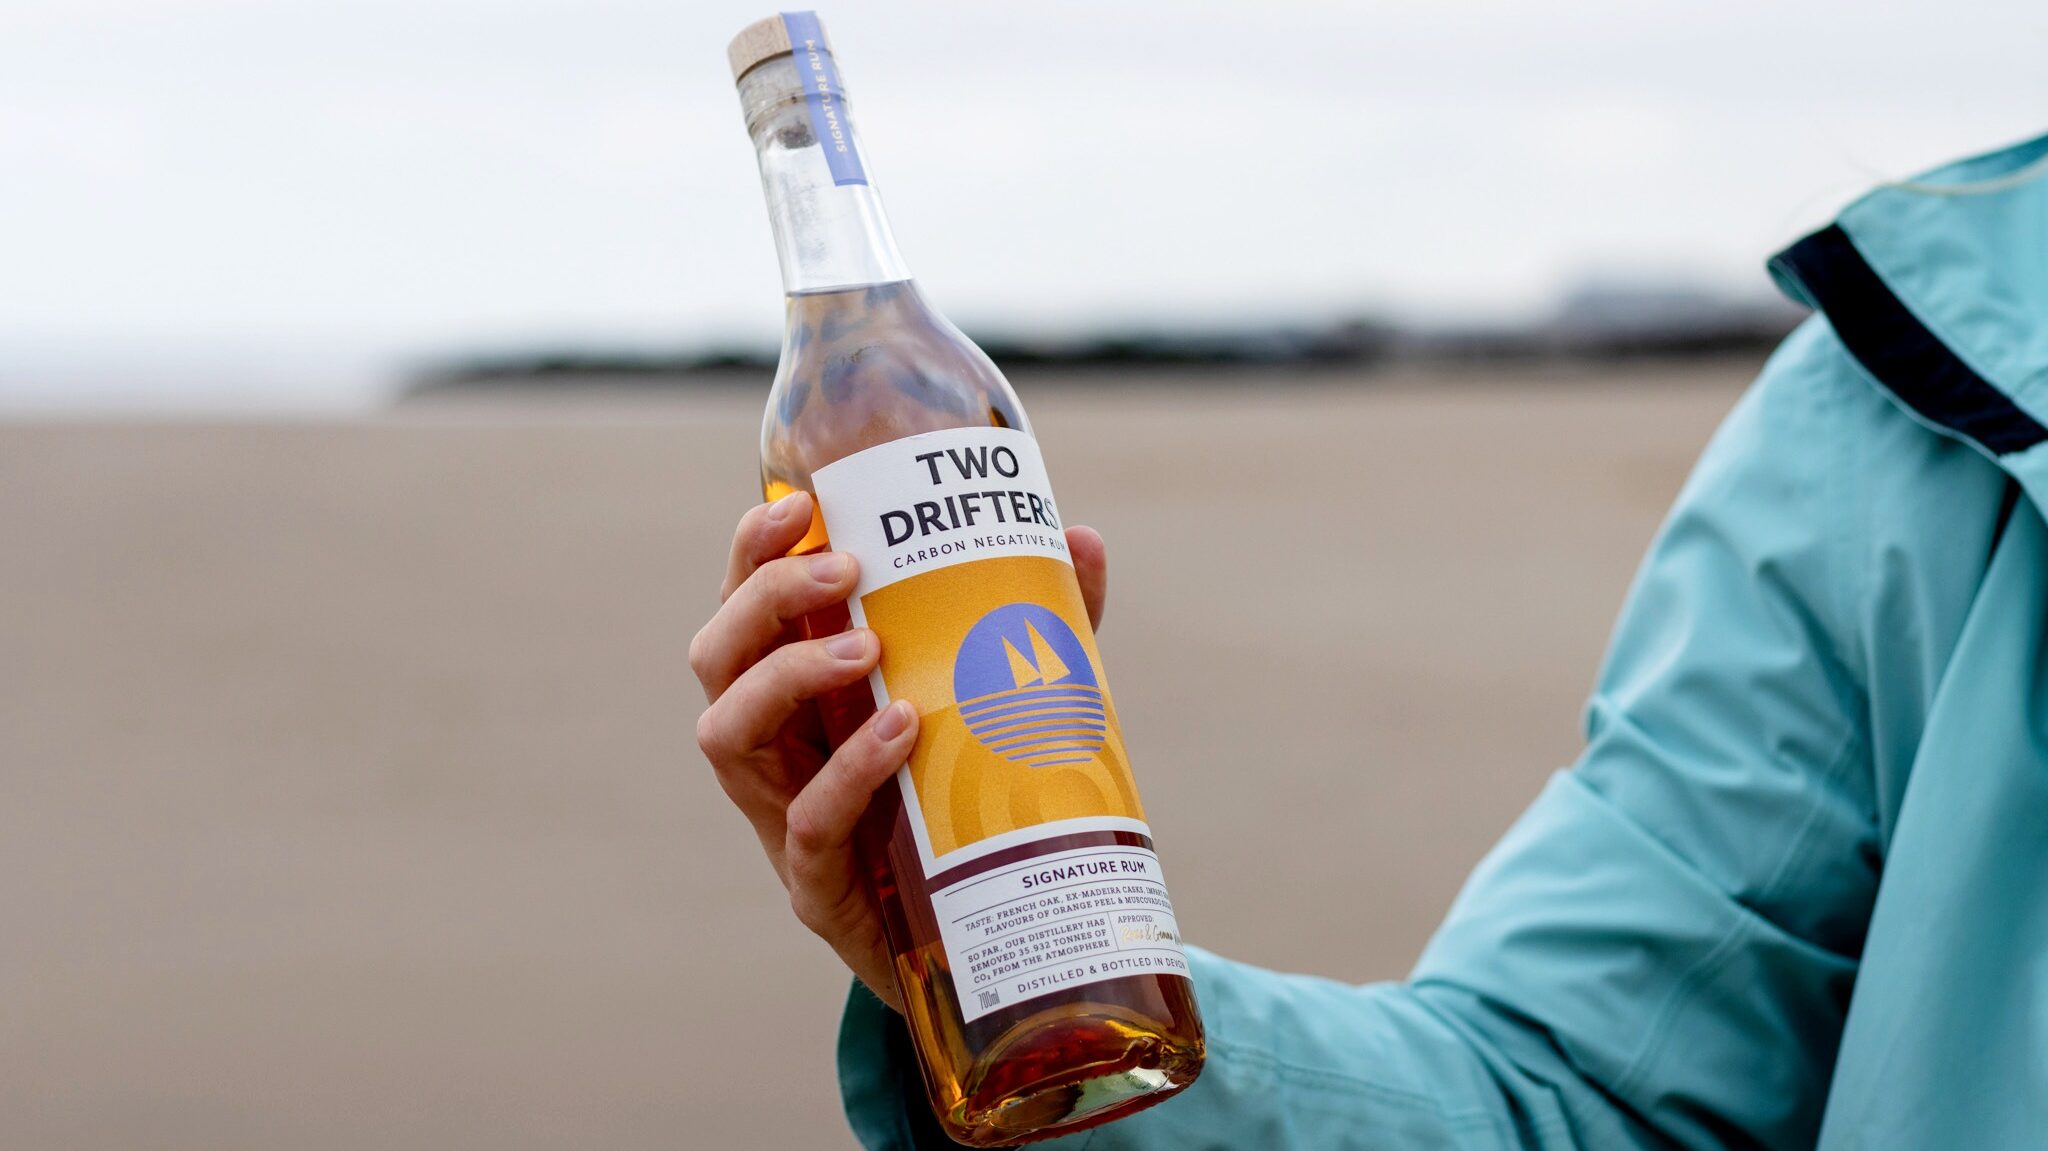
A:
<box><xmin>739</xmin><ymin>45</ymin><xmax>909</xmax><ymax>295</ymax></box>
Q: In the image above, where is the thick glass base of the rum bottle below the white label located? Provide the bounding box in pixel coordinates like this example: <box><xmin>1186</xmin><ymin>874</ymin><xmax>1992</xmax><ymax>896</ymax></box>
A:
<box><xmin>940</xmin><ymin>1006</ymin><xmax>1202</xmax><ymax>1147</ymax></box>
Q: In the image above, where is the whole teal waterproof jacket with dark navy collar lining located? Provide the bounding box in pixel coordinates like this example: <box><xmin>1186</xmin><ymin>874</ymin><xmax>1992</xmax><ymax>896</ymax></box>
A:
<box><xmin>840</xmin><ymin>137</ymin><xmax>2048</xmax><ymax>1151</ymax></box>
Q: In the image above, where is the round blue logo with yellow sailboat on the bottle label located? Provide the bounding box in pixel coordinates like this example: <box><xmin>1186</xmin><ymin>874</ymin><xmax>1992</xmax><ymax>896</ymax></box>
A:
<box><xmin>952</xmin><ymin>604</ymin><xmax>1108</xmax><ymax>768</ymax></box>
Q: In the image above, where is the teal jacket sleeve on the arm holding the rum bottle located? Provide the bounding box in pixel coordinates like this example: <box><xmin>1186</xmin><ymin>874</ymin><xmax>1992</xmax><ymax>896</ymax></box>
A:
<box><xmin>840</xmin><ymin>322</ymin><xmax>1997</xmax><ymax>1151</ymax></box>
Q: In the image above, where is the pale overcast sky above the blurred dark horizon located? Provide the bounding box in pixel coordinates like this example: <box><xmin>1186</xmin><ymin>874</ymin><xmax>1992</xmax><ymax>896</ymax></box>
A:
<box><xmin>0</xmin><ymin>0</ymin><xmax>2048</xmax><ymax>408</ymax></box>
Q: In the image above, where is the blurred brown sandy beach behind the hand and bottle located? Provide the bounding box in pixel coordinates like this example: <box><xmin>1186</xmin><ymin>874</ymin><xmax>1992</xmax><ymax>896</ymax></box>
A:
<box><xmin>0</xmin><ymin>360</ymin><xmax>1757</xmax><ymax>1151</ymax></box>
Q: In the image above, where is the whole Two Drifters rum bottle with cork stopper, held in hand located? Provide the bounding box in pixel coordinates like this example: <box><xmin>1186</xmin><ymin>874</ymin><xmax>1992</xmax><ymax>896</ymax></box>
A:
<box><xmin>729</xmin><ymin>12</ymin><xmax>1202</xmax><ymax>1145</ymax></box>
